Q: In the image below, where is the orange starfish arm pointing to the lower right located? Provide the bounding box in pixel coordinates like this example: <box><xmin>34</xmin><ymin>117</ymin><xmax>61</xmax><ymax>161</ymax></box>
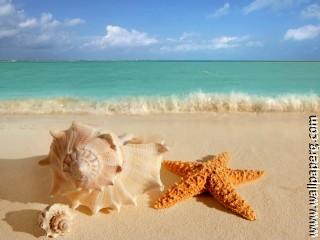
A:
<box><xmin>207</xmin><ymin>173</ymin><xmax>256</xmax><ymax>220</ymax></box>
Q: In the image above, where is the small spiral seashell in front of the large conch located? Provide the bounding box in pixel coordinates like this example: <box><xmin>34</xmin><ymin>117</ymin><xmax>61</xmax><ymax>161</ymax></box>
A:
<box><xmin>38</xmin><ymin>204</ymin><xmax>73</xmax><ymax>238</ymax></box>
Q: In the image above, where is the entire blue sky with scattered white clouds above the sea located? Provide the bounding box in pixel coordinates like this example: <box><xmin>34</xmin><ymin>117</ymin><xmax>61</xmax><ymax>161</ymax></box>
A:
<box><xmin>0</xmin><ymin>0</ymin><xmax>320</xmax><ymax>60</ymax></box>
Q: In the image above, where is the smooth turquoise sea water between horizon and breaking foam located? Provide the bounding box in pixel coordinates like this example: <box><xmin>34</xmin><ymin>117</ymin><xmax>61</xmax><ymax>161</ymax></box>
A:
<box><xmin>0</xmin><ymin>61</ymin><xmax>320</xmax><ymax>99</ymax></box>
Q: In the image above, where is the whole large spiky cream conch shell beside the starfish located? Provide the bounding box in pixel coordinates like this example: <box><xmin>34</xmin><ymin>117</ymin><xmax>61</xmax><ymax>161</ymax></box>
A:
<box><xmin>49</xmin><ymin>123</ymin><xmax>167</xmax><ymax>213</ymax></box>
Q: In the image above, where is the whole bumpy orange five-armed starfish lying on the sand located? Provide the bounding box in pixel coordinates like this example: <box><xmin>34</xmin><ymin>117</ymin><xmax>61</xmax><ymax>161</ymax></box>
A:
<box><xmin>154</xmin><ymin>152</ymin><xmax>264</xmax><ymax>220</ymax></box>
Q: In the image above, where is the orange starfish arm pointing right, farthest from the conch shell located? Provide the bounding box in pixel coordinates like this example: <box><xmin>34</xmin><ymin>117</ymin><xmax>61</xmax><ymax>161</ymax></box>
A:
<box><xmin>226</xmin><ymin>169</ymin><xmax>264</xmax><ymax>185</ymax></box>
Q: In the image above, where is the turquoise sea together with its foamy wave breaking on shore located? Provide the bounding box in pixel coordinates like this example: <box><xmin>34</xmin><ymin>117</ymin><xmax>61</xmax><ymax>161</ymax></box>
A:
<box><xmin>0</xmin><ymin>61</ymin><xmax>320</xmax><ymax>114</ymax></box>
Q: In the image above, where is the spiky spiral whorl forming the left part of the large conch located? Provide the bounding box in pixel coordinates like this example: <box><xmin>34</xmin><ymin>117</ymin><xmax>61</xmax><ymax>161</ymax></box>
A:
<box><xmin>49</xmin><ymin>123</ymin><xmax>123</xmax><ymax>195</ymax></box>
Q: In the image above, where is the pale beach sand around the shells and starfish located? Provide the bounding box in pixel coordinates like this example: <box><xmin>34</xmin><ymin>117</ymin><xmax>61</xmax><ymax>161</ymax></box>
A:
<box><xmin>0</xmin><ymin>113</ymin><xmax>308</xmax><ymax>240</ymax></box>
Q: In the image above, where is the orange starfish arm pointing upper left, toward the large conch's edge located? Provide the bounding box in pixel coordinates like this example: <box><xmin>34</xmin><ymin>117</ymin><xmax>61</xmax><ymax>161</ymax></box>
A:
<box><xmin>162</xmin><ymin>160</ymin><xmax>202</xmax><ymax>177</ymax></box>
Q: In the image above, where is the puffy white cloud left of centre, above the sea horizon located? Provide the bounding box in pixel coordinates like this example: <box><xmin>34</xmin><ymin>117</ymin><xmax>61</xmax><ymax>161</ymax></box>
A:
<box><xmin>85</xmin><ymin>25</ymin><xmax>158</xmax><ymax>48</ymax></box>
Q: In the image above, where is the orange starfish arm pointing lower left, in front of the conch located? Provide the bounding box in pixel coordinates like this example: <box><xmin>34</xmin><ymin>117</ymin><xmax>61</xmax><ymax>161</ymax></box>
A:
<box><xmin>154</xmin><ymin>172</ymin><xmax>208</xmax><ymax>209</ymax></box>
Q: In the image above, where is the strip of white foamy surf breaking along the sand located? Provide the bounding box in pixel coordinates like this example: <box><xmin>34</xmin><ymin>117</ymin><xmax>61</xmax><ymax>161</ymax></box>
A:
<box><xmin>0</xmin><ymin>92</ymin><xmax>320</xmax><ymax>115</ymax></box>
